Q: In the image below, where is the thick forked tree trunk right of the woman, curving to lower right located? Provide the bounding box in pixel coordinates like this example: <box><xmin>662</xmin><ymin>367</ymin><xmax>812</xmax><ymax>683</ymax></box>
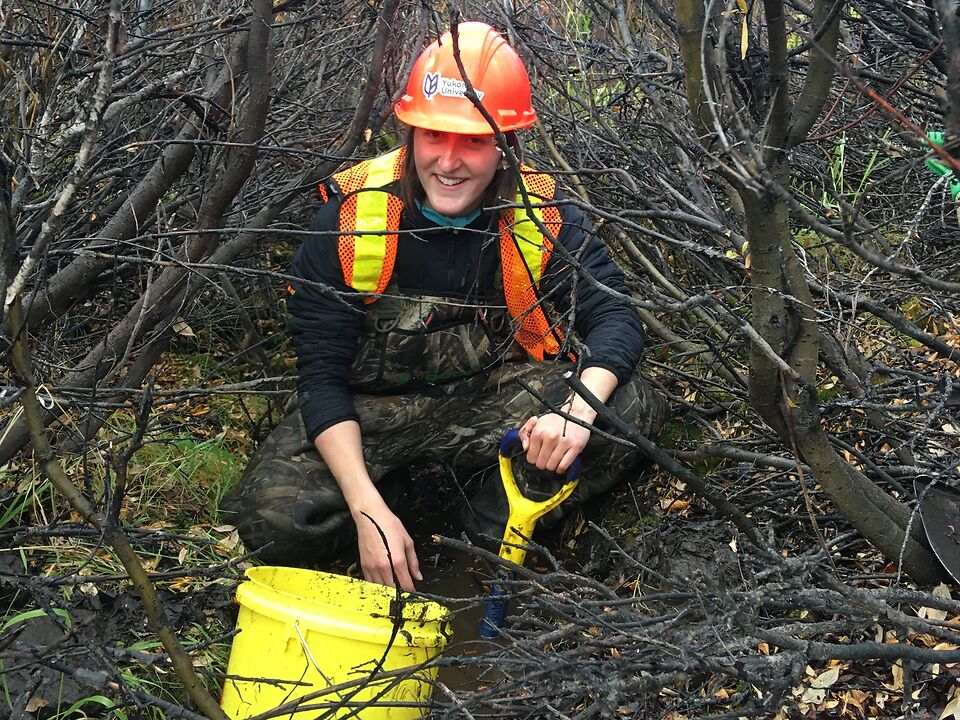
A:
<box><xmin>677</xmin><ymin>0</ymin><xmax>944</xmax><ymax>584</ymax></box>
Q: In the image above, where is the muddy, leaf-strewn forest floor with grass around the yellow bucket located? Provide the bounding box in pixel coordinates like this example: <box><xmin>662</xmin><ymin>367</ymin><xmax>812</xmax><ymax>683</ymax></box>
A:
<box><xmin>0</xmin><ymin>380</ymin><xmax>960</xmax><ymax>720</ymax></box>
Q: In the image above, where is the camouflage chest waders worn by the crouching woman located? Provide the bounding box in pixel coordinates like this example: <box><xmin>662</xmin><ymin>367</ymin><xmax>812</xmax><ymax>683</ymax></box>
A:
<box><xmin>223</xmin><ymin>290</ymin><xmax>664</xmax><ymax>565</ymax></box>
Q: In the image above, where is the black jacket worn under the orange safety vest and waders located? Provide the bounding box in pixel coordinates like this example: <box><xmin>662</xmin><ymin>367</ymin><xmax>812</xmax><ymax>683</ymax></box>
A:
<box><xmin>288</xmin><ymin>181</ymin><xmax>643</xmax><ymax>439</ymax></box>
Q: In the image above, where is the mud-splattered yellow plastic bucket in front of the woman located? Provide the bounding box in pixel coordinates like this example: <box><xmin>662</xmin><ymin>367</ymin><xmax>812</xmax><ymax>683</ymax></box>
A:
<box><xmin>220</xmin><ymin>567</ymin><xmax>450</xmax><ymax>720</ymax></box>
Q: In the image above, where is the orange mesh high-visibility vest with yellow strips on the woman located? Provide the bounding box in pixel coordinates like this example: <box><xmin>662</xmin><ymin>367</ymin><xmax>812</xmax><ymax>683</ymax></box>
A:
<box><xmin>320</xmin><ymin>148</ymin><xmax>563</xmax><ymax>360</ymax></box>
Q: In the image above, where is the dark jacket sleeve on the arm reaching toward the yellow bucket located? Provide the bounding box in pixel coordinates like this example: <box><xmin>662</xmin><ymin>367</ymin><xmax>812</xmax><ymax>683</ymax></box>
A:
<box><xmin>287</xmin><ymin>198</ymin><xmax>365</xmax><ymax>441</ymax></box>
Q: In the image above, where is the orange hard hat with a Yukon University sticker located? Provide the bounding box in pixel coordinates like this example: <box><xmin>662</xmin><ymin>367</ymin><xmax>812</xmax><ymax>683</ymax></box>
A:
<box><xmin>394</xmin><ymin>22</ymin><xmax>537</xmax><ymax>135</ymax></box>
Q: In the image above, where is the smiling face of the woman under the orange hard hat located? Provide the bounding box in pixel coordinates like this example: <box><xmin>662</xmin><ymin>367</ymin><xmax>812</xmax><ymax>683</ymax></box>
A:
<box><xmin>413</xmin><ymin>128</ymin><xmax>502</xmax><ymax>217</ymax></box>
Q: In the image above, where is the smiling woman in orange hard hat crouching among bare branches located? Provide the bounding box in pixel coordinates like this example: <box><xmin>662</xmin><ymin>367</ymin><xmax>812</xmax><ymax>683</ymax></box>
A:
<box><xmin>225</xmin><ymin>22</ymin><xmax>661</xmax><ymax>589</ymax></box>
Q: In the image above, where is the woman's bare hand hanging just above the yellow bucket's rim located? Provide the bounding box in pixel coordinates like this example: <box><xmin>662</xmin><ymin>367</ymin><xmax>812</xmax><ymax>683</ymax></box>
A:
<box><xmin>353</xmin><ymin>500</ymin><xmax>423</xmax><ymax>590</ymax></box>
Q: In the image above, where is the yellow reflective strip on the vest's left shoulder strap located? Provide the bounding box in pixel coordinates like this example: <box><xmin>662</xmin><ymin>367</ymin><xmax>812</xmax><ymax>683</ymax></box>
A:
<box><xmin>351</xmin><ymin>153</ymin><xmax>396</xmax><ymax>292</ymax></box>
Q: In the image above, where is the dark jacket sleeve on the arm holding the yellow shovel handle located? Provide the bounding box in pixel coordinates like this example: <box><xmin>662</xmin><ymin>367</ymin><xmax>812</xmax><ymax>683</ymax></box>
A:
<box><xmin>541</xmin><ymin>193</ymin><xmax>644</xmax><ymax>384</ymax></box>
